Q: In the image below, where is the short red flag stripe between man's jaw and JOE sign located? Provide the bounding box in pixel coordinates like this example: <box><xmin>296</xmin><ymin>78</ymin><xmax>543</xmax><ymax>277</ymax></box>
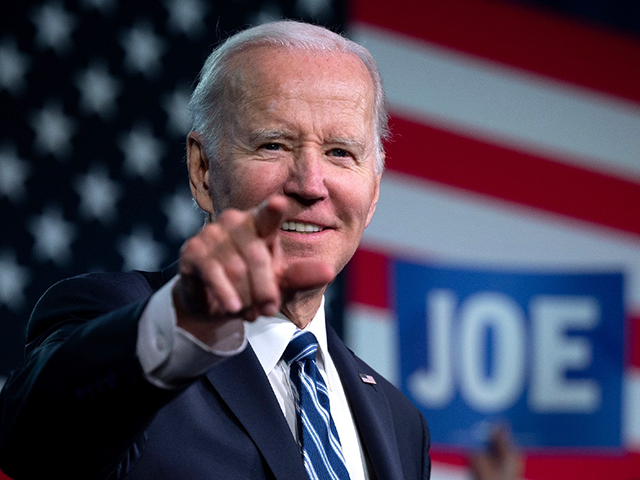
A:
<box><xmin>347</xmin><ymin>249</ymin><xmax>389</xmax><ymax>309</ymax></box>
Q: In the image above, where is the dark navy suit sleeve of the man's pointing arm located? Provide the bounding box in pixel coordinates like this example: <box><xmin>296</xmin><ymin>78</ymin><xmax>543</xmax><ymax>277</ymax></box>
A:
<box><xmin>0</xmin><ymin>273</ymin><xmax>181</xmax><ymax>479</ymax></box>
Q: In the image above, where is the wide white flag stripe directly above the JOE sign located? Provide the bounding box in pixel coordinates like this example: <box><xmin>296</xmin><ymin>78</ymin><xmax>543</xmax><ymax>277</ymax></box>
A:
<box><xmin>362</xmin><ymin>172</ymin><xmax>640</xmax><ymax>312</ymax></box>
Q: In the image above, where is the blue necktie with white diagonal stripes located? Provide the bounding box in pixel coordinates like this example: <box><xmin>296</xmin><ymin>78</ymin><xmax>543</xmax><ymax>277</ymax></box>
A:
<box><xmin>282</xmin><ymin>330</ymin><xmax>349</xmax><ymax>480</ymax></box>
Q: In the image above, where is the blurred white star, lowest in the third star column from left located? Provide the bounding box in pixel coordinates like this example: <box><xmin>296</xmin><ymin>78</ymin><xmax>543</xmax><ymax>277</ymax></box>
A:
<box><xmin>74</xmin><ymin>165</ymin><xmax>122</xmax><ymax>223</ymax></box>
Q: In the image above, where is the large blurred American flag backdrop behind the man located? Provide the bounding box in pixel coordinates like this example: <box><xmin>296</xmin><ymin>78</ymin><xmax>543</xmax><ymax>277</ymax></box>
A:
<box><xmin>0</xmin><ymin>0</ymin><xmax>640</xmax><ymax>480</ymax></box>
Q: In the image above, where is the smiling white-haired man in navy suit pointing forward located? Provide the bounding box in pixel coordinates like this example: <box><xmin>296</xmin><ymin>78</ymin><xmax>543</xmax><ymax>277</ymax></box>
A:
<box><xmin>0</xmin><ymin>22</ymin><xmax>430</xmax><ymax>479</ymax></box>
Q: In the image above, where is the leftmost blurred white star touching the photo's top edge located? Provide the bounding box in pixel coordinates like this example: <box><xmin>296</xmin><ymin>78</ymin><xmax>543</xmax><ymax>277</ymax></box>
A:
<box><xmin>31</xmin><ymin>2</ymin><xmax>78</xmax><ymax>55</ymax></box>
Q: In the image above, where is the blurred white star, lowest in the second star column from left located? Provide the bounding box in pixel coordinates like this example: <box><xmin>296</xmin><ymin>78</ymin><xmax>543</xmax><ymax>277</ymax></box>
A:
<box><xmin>29</xmin><ymin>206</ymin><xmax>76</xmax><ymax>266</ymax></box>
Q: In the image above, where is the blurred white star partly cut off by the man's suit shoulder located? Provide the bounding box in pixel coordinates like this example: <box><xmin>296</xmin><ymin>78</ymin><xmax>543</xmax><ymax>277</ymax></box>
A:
<box><xmin>118</xmin><ymin>227</ymin><xmax>165</xmax><ymax>271</ymax></box>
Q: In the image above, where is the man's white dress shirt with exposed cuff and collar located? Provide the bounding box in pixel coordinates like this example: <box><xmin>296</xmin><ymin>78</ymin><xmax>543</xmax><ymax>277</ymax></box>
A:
<box><xmin>137</xmin><ymin>276</ymin><xmax>369</xmax><ymax>480</ymax></box>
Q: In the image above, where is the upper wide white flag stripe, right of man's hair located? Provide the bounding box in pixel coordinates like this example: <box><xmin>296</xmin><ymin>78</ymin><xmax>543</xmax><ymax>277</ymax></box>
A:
<box><xmin>351</xmin><ymin>20</ymin><xmax>640</xmax><ymax>181</ymax></box>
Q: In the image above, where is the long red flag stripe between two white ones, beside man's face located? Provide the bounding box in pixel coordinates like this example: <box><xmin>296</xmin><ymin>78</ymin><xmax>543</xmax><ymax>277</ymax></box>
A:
<box><xmin>387</xmin><ymin>116</ymin><xmax>640</xmax><ymax>235</ymax></box>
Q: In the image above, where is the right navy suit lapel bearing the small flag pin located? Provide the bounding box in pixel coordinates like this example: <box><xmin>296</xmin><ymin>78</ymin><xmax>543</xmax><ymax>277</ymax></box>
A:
<box><xmin>327</xmin><ymin>327</ymin><xmax>402</xmax><ymax>478</ymax></box>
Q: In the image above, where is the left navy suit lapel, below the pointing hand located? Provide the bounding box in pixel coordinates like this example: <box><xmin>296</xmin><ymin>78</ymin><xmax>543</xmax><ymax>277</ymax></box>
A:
<box><xmin>207</xmin><ymin>345</ymin><xmax>308</xmax><ymax>480</ymax></box>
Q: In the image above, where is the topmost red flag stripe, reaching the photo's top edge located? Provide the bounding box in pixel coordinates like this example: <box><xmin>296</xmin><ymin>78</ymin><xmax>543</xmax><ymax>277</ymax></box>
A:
<box><xmin>351</xmin><ymin>0</ymin><xmax>640</xmax><ymax>102</ymax></box>
